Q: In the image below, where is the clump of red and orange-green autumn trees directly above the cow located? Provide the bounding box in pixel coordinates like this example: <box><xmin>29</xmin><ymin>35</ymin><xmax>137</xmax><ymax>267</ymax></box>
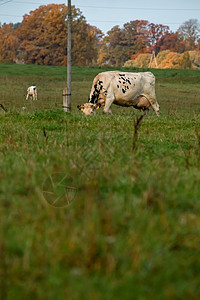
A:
<box><xmin>98</xmin><ymin>20</ymin><xmax>169</xmax><ymax>65</ymax></box>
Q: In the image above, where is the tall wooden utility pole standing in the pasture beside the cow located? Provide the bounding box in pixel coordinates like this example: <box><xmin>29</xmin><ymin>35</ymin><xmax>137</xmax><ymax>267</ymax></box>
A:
<box><xmin>63</xmin><ymin>0</ymin><xmax>72</xmax><ymax>112</ymax></box>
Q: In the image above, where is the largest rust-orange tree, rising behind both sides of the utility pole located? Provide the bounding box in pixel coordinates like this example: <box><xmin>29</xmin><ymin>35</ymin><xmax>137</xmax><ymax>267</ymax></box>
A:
<box><xmin>18</xmin><ymin>4</ymin><xmax>101</xmax><ymax>65</ymax></box>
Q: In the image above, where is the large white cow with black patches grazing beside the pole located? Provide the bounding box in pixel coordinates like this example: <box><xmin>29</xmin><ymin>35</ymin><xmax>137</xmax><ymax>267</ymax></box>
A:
<box><xmin>78</xmin><ymin>71</ymin><xmax>159</xmax><ymax>115</ymax></box>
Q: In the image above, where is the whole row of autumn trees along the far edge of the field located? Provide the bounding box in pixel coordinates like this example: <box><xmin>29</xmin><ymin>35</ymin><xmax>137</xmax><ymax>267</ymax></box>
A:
<box><xmin>0</xmin><ymin>4</ymin><xmax>200</xmax><ymax>68</ymax></box>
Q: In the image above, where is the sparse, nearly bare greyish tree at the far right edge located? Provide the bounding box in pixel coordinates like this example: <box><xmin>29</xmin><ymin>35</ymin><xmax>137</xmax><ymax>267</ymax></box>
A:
<box><xmin>177</xmin><ymin>19</ymin><xmax>200</xmax><ymax>50</ymax></box>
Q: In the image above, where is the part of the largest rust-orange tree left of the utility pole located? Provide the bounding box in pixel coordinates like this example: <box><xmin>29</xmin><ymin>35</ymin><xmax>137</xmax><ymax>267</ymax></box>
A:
<box><xmin>18</xmin><ymin>5</ymin><xmax>66</xmax><ymax>64</ymax></box>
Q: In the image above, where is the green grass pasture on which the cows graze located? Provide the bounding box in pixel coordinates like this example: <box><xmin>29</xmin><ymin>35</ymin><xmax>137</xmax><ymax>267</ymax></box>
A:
<box><xmin>0</xmin><ymin>65</ymin><xmax>200</xmax><ymax>300</ymax></box>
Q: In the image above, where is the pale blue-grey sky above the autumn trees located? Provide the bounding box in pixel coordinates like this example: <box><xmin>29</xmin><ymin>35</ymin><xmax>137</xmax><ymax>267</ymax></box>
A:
<box><xmin>0</xmin><ymin>0</ymin><xmax>200</xmax><ymax>33</ymax></box>
